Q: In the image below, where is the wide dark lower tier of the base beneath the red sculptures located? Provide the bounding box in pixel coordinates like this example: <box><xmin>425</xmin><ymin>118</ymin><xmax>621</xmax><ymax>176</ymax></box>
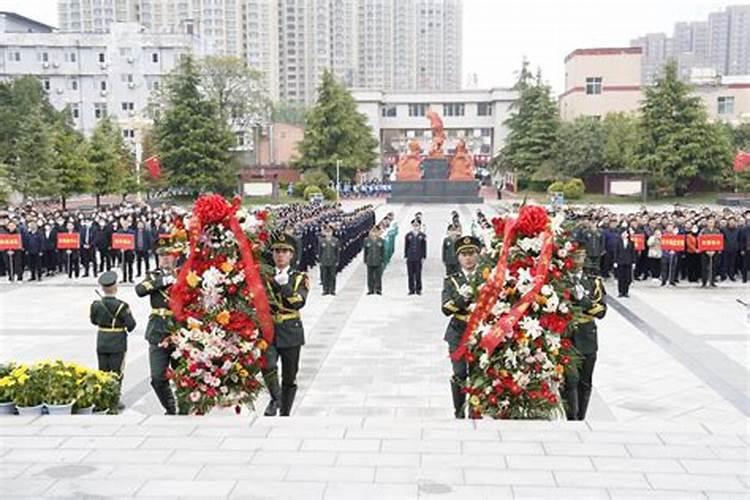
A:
<box><xmin>388</xmin><ymin>179</ymin><xmax>483</xmax><ymax>204</ymax></box>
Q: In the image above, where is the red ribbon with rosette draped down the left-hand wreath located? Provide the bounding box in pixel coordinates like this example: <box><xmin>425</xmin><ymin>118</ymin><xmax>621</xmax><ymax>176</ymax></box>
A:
<box><xmin>169</xmin><ymin>194</ymin><xmax>274</xmax><ymax>344</ymax></box>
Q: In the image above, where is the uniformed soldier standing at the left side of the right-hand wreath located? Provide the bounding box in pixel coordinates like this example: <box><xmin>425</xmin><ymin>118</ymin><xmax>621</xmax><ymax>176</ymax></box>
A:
<box><xmin>442</xmin><ymin>236</ymin><xmax>484</xmax><ymax>418</ymax></box>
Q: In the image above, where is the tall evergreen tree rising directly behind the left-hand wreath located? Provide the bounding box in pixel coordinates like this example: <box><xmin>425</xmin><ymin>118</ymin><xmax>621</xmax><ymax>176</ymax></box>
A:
<box><xmin>154</xmin><ymin>57</ymin><xmax>238</xmax><ymax>194</ymax></box>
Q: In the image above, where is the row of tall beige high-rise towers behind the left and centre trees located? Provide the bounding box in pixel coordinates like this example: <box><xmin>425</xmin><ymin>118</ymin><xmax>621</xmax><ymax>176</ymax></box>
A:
<box><xmin>58</xmin><ymin>0</ymin><xmax>463</xmax><ymax>103</ymax></box>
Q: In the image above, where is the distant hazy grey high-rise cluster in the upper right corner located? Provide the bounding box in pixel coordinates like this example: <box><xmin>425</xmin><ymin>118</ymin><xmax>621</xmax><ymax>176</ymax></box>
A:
<box><xmin>631</xmin><ymin>5</ymin><xmax>750</xmax><ymax>84</ymax></box>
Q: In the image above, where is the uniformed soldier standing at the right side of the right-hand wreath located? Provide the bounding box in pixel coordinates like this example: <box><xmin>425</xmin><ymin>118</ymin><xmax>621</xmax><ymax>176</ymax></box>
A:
<box><xmin>564</xmin><ymin>251</ymin><xmax>608</xmax><ymax>420</ymax></box>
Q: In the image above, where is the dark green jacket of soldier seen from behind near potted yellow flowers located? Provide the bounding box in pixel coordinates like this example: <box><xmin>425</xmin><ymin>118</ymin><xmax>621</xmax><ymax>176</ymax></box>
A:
<box><xmin>90</xmin><ymin>297</ymin><xmax>135</xmax><ymax>353</ymax></box>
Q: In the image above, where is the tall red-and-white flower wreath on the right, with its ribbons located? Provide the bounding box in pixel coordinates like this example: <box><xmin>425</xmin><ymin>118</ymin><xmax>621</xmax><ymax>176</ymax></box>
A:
<box><xmin>453</xmin><ymin>206</ymin><xmax>580</xmax><ymax>419</ymax></box>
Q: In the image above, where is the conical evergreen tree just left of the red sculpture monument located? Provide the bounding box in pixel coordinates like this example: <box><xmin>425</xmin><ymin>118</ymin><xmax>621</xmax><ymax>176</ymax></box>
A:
<box><xmin>295</xmin><ymin>71</ymin><xmax>378</xmax><ymax>179</ymax></box>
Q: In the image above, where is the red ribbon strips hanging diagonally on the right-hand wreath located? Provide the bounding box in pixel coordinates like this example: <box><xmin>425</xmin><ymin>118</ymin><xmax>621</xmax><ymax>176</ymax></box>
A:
<box><xmin>451</xmin><ymin>207</ymin><xmax>554</xmax><ymax>361</ymax></box>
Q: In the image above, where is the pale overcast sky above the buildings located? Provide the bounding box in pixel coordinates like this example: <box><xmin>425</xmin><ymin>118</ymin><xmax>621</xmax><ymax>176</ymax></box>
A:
<box><xmin>0</xmin><ymin>0</ymin><xmax>743</xmax><ymax>93</ymax></box>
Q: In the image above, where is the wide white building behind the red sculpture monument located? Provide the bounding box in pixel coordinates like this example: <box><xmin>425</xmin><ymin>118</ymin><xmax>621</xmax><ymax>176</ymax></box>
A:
<box><xmin>352</xmin><ymin>88</ymin><xmax>517</xmax><ymax>176</ymax></box>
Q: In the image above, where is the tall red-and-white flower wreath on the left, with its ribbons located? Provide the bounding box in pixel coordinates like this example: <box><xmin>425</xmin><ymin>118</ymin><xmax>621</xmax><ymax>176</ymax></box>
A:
<box><xmin>166</xmin><ymin>195</ymin><xmax>273</xmax><ymax>414</ymax></box>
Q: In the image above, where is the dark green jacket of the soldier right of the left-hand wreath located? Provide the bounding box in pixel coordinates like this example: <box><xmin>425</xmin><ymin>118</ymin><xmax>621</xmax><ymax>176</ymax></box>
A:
<box><xmin>266</xmin><ymin>268</ymin><xmax>310</xmax><ymax>348</ymax></box>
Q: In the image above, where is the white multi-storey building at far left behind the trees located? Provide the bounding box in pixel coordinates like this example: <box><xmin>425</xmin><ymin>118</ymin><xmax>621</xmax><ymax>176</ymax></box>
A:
<box><xmin>0</xmin><ymin>23</ymin><xmax>204</xmax><ymax>138</ymax></box>
